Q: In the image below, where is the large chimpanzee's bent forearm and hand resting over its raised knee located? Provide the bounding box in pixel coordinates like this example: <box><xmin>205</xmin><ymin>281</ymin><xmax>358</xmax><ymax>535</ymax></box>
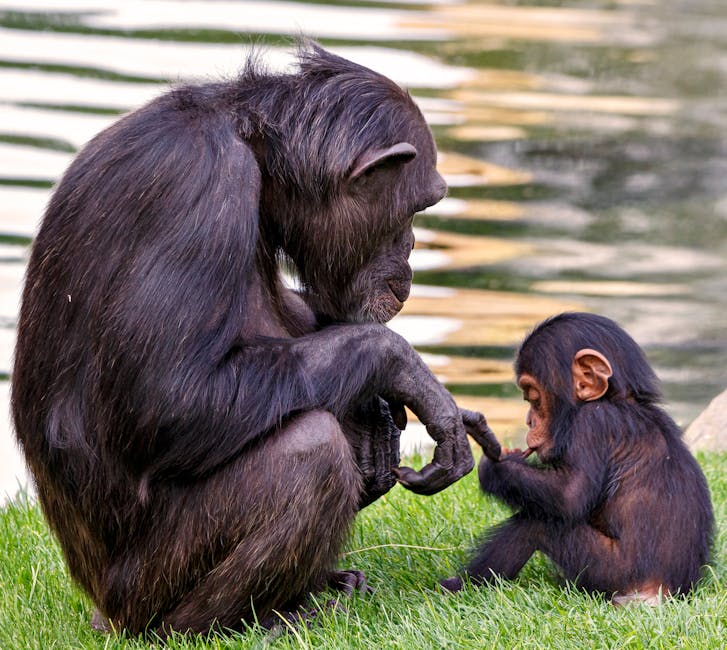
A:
<box><xmin>121</xmin><ymin>325</ymin><xmax>473</xmax><ymax>493</ymax></box>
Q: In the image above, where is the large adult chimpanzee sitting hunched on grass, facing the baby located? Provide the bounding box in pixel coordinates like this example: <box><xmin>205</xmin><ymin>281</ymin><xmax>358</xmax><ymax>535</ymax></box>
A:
<box><xmin>13</xmin><ymin>44</ymin><xmax>496</xmax><ymax>634</ymax></box>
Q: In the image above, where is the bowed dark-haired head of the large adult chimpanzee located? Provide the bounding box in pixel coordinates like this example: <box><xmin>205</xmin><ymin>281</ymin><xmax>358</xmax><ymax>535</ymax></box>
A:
<box><xmin>266</xmin><ymin>45</ymin><xmax>447</xmax><ymax>322</ymax></box>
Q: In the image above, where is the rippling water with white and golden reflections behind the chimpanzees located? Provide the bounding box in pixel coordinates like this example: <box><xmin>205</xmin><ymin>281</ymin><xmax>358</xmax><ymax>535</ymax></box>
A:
<box><xmin>0</xmin><ymin>0</ymin><xmax>727</xmax><ymax>493</ymax></box>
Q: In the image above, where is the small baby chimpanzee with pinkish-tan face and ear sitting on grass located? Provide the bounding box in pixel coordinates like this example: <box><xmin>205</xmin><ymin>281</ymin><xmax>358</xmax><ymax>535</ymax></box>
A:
<box><xmin>442</xmin><ymin>313</ymin><xmax>713</xmax><ymax>603</ymax></box>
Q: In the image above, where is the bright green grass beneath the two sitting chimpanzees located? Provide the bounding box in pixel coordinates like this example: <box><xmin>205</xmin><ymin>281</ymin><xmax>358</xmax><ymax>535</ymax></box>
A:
<box><xmin>0</xmin><ymin>453</ymin><xmax>727</xmax><ymax>650</ymax></box>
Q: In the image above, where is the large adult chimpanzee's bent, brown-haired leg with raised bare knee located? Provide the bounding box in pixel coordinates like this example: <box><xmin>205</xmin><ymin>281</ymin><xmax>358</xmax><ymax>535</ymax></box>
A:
<box><xmin>102</xmin><ymin>411</ymin><xmax>361</xmax><ymax>634</ymax></box>
